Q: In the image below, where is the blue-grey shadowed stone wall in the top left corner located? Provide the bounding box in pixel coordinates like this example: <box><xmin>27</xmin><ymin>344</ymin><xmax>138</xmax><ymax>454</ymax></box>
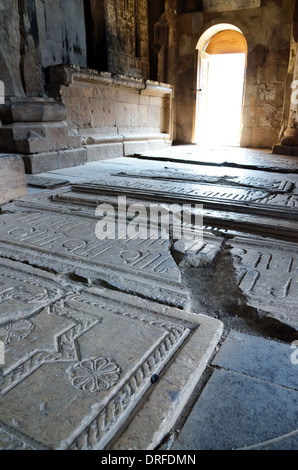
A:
<box><xmin>0</xmin><ymin>0</ymin><xmax>87</xmax><ymax>97</ymax></box>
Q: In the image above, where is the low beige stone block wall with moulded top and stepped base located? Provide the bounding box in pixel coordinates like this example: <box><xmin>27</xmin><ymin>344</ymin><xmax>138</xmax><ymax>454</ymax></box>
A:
<box><xmin>48</xmin><ymin>66</ymin><xmax>172</xmax><ymax>161</ymax></box>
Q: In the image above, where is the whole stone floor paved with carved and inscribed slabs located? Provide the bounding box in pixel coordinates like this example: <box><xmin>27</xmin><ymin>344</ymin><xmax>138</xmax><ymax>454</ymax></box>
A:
<box><xmin>0</xmin><ymin>146</ymin><xmax>298</xmax><ymax>451</ymax></box>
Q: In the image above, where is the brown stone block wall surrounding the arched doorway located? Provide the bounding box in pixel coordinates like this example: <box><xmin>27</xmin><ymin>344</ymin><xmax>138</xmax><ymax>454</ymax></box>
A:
<box><xmin>167</xmin><ymin>0</ymin><xmax>295</xmax><ymax>148</ymax></box>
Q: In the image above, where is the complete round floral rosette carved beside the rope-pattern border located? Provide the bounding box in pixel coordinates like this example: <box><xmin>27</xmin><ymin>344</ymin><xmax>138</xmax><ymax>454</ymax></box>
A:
<box><xmin>70</xmin><ymin>357</ymin><xmax>121</xmax><ymax>393</ymax></box>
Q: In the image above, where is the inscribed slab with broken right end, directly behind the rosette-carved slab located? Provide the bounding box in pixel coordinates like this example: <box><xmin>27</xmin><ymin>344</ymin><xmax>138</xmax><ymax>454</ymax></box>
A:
<box><xmin>0</xmin><ymin>211</ymin><xmax>190</xmax><ymax>308</ymax></box>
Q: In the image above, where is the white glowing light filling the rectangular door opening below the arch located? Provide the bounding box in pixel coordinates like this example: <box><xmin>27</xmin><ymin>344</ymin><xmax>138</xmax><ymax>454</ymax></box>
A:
<box><xmin>203</xmin><ymin>54</ymin><xmax>246</xmax><ymax>146</ymax></box>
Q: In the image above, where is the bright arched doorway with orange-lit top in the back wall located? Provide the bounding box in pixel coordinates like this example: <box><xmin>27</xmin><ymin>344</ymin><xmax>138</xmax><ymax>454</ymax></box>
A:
<box><xmin>194</xmin><ymin>24</ymin><xmax>247</xmax><ymax>145</ymax></box>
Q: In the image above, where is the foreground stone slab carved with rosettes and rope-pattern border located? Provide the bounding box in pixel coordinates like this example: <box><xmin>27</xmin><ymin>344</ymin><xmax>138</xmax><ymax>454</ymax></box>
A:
<box><xmin>0</xmin><ymin>288</ymin><xmax>223</xmax><ymax>450</ymax></box>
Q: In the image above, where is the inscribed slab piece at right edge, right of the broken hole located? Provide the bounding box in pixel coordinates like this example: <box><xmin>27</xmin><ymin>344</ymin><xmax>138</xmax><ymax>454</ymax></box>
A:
<box><xmin>231</xmin><ymin>237</ymin><xmax>298</xmax><ymax>330</ymax></box>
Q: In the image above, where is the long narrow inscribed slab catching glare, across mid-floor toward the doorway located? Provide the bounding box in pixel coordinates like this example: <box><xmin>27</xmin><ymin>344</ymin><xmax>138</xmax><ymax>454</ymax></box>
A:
<box><xmin>72</xmin><ymin>177</ymin><xmax>298</xmax><ymax>218</ymax></box>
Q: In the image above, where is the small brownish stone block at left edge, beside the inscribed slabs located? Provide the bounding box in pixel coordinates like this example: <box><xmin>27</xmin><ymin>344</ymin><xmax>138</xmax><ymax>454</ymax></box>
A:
<box><xmin>0</xmin><ymin>155</ymin><xmax>27</xmax><ymax>204</ymax></box>
